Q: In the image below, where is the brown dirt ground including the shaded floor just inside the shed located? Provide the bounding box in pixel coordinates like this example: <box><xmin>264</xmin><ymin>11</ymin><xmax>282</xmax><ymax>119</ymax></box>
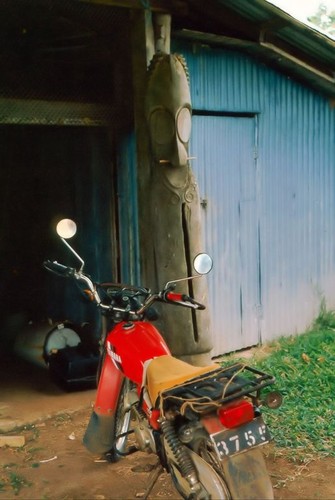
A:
<box><xmin>0</xmin><ymin>354</ymin><xmax>335</xmax><ymax>500</ymax></box>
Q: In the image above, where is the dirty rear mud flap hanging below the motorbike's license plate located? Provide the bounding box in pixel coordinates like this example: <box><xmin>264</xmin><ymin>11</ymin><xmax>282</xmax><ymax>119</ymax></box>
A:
<box><xmin>222</xmin><ymin>448</ymin><xmax>274</xmax><ymax>500</ymax></box>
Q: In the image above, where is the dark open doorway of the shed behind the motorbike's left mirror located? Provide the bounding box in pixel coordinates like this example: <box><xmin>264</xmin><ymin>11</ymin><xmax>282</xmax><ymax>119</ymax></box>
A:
<box><xmin>0</xmin><ymin>126</ymin><xmax>117</xmax><ymax>347</ymax></box>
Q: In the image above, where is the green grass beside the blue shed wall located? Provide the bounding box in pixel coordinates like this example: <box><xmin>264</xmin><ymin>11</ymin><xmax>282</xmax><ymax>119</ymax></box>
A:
<box><xmin>220</xmin><ymin>307</ymin><xmax>335</xmax><ymax>457</ymax></box>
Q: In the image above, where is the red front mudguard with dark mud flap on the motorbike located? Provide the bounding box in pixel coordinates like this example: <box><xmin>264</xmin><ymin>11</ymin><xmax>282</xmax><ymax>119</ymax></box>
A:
<box><xmin>83</xmin><ymin>355</ymin><xmax>124</xmax><ymax>454</ymax></box>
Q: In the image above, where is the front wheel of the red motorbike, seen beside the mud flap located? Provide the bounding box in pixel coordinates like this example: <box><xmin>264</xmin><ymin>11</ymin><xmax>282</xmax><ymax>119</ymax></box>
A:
<box><xmin>106</xmin><ymin>378</ymin><xmax>131</xmax><ymax>462</ymax></box>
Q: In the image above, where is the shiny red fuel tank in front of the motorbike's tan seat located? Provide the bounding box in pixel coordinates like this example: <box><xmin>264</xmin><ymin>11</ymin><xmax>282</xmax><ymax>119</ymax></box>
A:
<box><xmin>107</xmin><ymin>321</ymin><xmax>171</xmax><ymax>385</ymax></box>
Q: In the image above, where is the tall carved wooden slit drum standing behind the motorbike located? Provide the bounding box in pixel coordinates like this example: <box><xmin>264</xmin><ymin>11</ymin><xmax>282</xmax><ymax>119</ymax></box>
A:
<box><xmin>146</xmin><ymin>53</ymin><xmax>212</xmax><ymax>364</ymax></box>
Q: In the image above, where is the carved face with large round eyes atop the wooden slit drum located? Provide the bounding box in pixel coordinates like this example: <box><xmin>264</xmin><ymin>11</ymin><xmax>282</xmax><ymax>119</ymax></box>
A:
<box><xmin>146</xmin><ymin>54</ymin><xmax>192</xmax><ymax>167</ymax></box>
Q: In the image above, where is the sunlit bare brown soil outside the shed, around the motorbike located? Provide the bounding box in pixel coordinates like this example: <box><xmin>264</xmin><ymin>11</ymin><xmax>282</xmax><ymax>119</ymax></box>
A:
<box><xmin>0</xmin><ymin>409</ymin><xmax>335</xmax><ymax>500</ymax></box>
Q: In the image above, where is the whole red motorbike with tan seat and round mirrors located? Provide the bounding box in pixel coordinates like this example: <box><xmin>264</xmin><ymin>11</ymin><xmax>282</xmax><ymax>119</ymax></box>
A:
<box><xmin>44</xmin><ymin>219</ymin><xmax>281</xmax><ymax>500</ymax></box>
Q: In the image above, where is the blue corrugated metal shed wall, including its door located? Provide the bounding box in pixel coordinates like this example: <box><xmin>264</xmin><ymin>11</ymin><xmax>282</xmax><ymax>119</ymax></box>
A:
<box><xmin>177</xmin><ymin>45</ymin><xmax>335</xmax><ymax>355</ymax></box>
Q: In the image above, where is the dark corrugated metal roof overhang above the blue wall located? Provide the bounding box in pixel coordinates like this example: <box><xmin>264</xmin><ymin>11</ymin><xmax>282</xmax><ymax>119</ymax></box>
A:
<box><xmin>173</xmin><ymin>0</ymin><xmax>335</xmax><ymax>98</ymax></box>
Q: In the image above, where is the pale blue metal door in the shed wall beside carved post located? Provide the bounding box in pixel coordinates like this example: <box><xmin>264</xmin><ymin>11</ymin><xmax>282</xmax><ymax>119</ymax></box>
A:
<box><xmin>192</xmin><ymin>115</ymin><xmax>261</xmax><ymax>350</ymax></box>
